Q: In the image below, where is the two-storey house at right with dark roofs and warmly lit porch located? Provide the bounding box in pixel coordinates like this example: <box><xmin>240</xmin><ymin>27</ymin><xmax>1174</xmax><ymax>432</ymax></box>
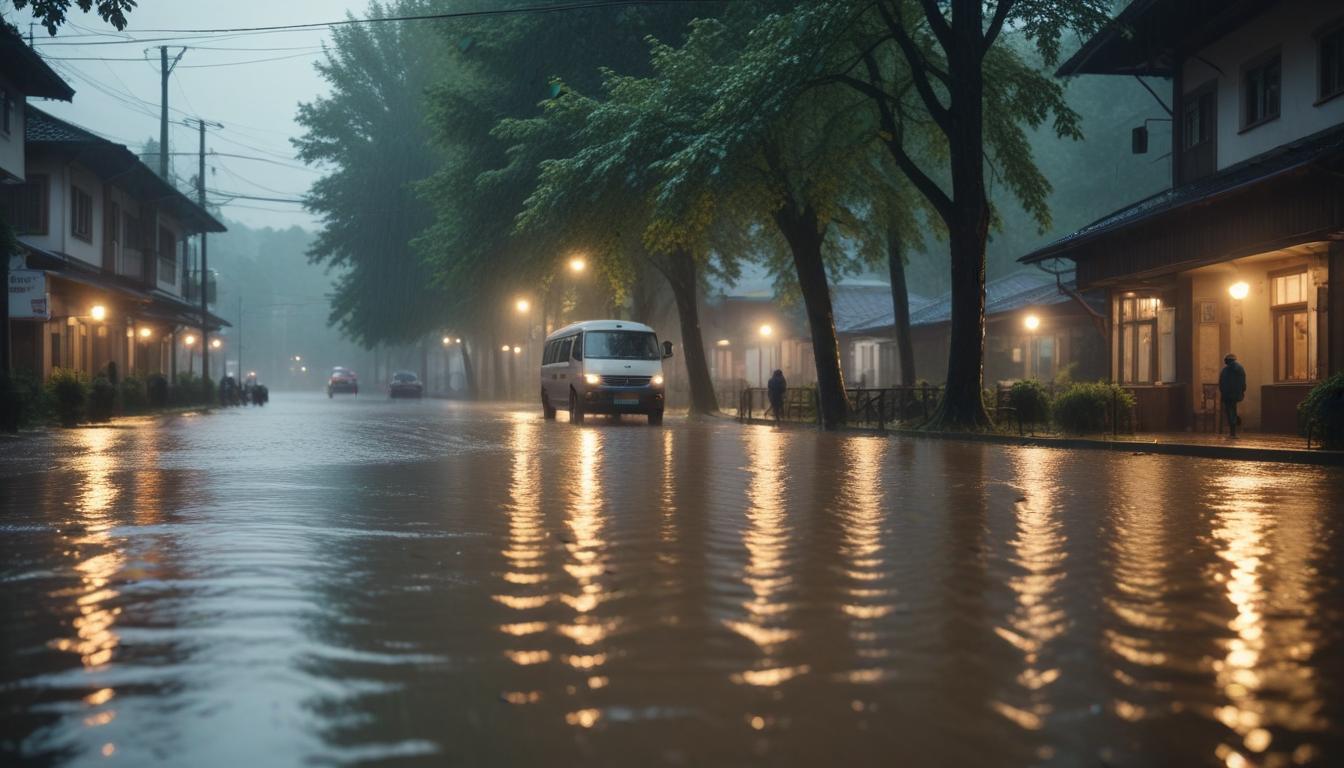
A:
<box><xmin>1021</xmin><ymin>0</ymin><xmax>1344</xmax><ymax>432</ymax></box>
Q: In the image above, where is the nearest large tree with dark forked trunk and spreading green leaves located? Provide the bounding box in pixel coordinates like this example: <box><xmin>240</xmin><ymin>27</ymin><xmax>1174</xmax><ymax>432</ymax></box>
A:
<box><xmin>837</xmin><ymin>0</ymin><xmax>1109</xmax><ymax>429</ymax></box>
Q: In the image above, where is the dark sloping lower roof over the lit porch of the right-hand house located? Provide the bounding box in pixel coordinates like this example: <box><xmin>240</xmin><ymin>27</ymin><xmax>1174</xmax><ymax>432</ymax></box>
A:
<box><xmin>1017</xmin><ymin>119</ymin><xmax>1344</xmax><ymax>264</ymax></box>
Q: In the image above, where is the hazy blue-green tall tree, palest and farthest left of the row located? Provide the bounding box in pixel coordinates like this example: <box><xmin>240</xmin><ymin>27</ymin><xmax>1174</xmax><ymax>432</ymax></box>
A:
<box><xmin>294</xmin><ymin>0</ymin><xmax>444</xmax><ymax>347</ymax></box>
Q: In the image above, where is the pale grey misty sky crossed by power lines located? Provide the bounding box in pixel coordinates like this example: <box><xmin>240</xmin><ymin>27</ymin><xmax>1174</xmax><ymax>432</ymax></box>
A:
<box><xmin>14</xmin><ymin>0</ymin><xmax>366</xmax><ymax>227</ymax></box>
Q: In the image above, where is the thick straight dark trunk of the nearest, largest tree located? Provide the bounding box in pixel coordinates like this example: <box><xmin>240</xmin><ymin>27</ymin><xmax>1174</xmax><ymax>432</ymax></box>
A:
<box><xmin>930</xmin><ymin>0</ymin><xmax>992</xmax><ymax>429</ymax></box>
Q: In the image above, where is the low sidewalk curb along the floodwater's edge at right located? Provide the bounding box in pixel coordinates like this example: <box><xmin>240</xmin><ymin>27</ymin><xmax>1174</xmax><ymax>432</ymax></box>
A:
<box><xmin>739</xmin><ymin>418</ymin><xmax>1344</xmax><ymax>467</ymax></box>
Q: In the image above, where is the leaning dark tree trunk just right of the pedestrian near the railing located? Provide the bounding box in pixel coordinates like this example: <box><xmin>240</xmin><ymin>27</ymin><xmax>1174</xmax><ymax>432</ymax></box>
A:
<box><xmin>774</xmin><ymin>200</ymin><xmax>849</xmax><ymax>429</ymax></box>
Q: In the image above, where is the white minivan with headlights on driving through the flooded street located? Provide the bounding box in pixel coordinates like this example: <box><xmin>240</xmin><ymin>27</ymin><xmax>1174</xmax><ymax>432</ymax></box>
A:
<box><xmin>542</xmin><ymin>320</ymin><xmax>672</xmax><ymax>424</ymax></box>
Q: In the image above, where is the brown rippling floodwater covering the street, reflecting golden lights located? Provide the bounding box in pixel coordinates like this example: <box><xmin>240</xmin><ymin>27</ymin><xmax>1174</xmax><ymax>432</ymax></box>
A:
<box><xmin>0</xmin><ymin>393</ymin><xmax>1344</xmax><ymax>768</ymax></box>
